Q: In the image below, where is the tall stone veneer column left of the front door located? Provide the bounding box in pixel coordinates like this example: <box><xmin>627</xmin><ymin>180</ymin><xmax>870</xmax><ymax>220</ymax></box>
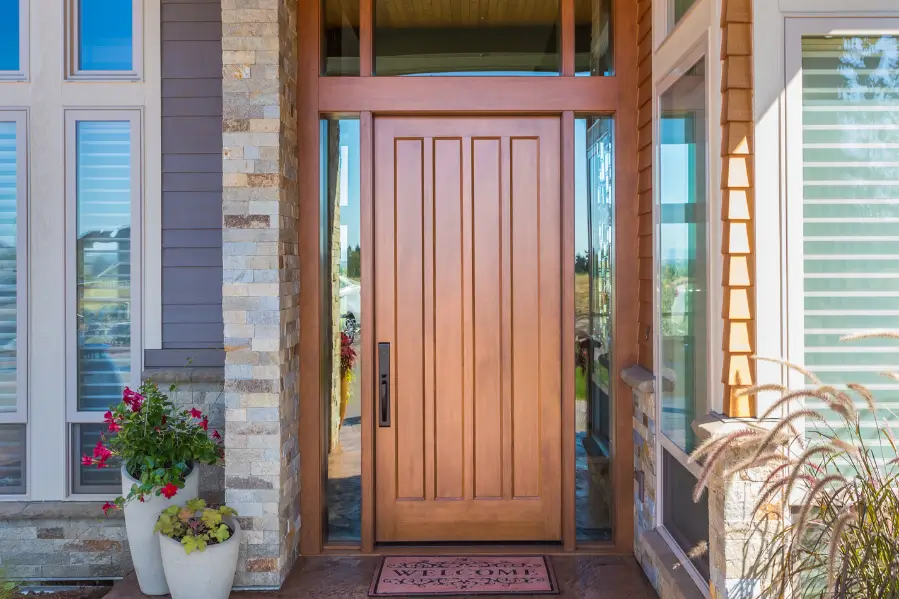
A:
<box><xmin>222</xmin><ymin>0</ymin><xmax>302</xmax><ymax>587</ymax></box>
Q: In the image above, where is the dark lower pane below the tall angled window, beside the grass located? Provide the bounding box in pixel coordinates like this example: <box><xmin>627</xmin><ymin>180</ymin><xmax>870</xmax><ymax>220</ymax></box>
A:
<box><xmin>662</xmin><ymin>449</ymin><xmax>709</xmax><ymax>580</ymax></box>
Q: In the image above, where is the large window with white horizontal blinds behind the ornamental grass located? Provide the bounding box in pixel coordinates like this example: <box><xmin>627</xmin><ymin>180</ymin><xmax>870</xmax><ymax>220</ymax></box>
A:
<box><xmin>802</xmin><ymin>35</ymin><xmax>899</xmax><ymax>443</ymax></box>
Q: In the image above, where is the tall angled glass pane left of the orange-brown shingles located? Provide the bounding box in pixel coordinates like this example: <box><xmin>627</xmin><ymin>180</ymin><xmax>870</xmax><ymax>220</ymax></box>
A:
<box><xmin>659</xmin><ymin>59</ymin><xmax>709</xmax><ymax>453</ymax></box>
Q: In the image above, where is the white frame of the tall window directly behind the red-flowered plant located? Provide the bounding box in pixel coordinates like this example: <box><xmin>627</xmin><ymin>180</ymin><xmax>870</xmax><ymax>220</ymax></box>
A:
<box><xmin>65</xmin><ymin>108</ymin><xmax>144</xmax><ymax>500</ymax></box>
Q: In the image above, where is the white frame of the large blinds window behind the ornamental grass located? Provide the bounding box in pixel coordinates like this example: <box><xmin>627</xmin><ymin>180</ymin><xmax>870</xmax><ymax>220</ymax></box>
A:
<box><xmin>783</xmin><ymin>13</ymin><xmax>899</xmax><ymax>388</ymax></box>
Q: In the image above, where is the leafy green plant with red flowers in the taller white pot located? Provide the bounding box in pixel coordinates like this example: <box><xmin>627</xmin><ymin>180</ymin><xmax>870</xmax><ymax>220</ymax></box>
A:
<box><xmin>81</xmin><ymin>381</ymin><xmax>224</xmax><ymax>513</ymax></box>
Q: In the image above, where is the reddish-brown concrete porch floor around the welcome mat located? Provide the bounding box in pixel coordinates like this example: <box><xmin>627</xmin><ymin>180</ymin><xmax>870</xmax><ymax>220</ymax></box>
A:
<box><xmin>105</xmin><ymin>556</ymin><xmax>657</xmax><ymax>599</ymax></box>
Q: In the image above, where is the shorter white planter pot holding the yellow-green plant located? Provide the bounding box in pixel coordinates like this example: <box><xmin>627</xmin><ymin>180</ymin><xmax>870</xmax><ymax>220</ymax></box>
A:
<box><xmin>157</xmin><ymin>516</ymin><xmax>240</xmax><ymax>599</ymax></box>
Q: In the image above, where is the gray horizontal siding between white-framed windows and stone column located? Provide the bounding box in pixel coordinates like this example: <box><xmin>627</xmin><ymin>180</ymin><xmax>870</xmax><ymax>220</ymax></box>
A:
<box><xmin>153</xmin><ymin>0</ymin><xmax>224</xmax><ymax>368</ymax></box>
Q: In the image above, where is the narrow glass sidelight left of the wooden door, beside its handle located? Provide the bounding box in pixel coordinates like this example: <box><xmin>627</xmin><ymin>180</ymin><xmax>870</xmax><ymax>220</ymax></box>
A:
<box><xmin>321</xmin><ymin>119</ymin><xmax>363</xmax><ymax>542</ymax></box>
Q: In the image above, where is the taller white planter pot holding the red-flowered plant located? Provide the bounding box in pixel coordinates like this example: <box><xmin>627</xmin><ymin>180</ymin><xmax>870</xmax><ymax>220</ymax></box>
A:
<box><xmin>122</xmin><ymin>465</ymin><xmax>200</xmax><ymax>595</ymax></box>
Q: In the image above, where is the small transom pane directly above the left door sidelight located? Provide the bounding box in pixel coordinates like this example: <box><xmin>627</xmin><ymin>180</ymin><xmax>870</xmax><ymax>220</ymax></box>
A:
<box><xmin>322</xmin><ymin>0</ymin><xmax>359</xmax><ymax>76</ymax></box>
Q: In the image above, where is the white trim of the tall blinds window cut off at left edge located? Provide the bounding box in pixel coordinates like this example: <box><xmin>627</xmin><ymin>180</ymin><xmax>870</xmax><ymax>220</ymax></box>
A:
<box><xmin>0</xmin><ymin>109</ymin><xmax>29</xmax><ymax>424</ymax></box>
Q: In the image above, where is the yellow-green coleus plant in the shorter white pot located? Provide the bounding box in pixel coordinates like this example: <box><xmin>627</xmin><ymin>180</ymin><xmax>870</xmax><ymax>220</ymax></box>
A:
<box><xmin>153</xmin><ymin>499</ymin><xmax>237</xmax><ymax>555</ymax></box>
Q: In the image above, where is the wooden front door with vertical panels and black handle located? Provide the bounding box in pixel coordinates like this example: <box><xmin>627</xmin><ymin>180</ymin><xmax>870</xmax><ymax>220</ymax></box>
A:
<box><xmin>374</xmin><ymin>117</ymin><xmax>562</xmax><ymax>542</ymax></box>
